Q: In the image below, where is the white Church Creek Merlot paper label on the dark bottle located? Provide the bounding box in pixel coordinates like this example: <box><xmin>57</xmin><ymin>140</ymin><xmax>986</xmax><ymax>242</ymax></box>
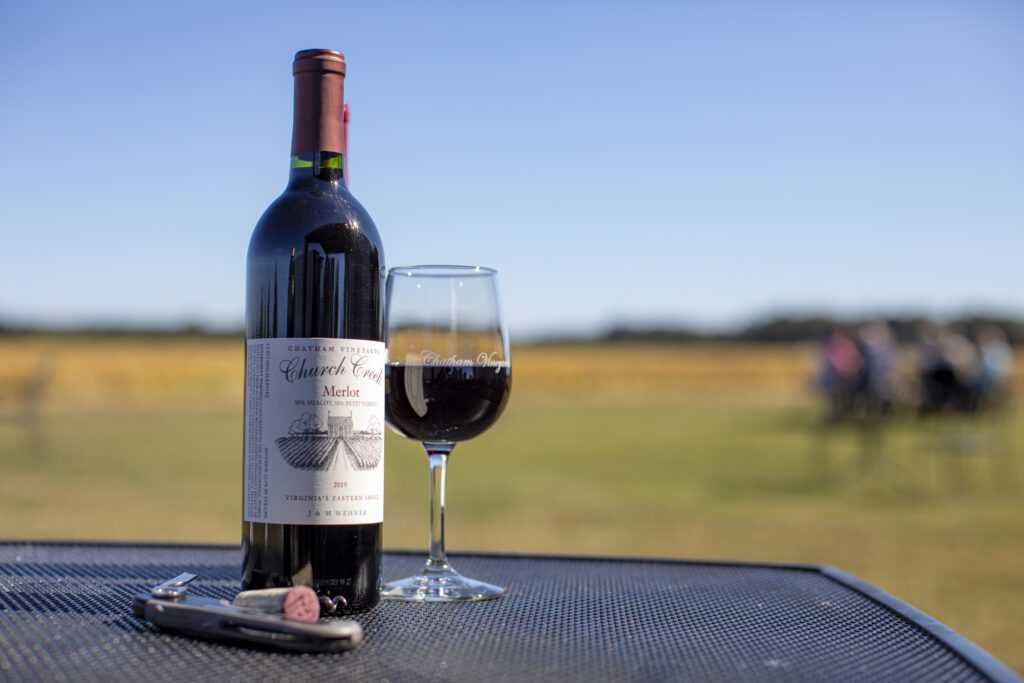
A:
<box><xmin>244</xmin><ymin>338</ymin><xmax>387</xmax><ymax>524</ymax></box>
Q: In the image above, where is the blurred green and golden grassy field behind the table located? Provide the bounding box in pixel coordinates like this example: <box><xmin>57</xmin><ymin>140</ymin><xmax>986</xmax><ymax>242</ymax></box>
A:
<box><xmin>0</xmin><ymin>338</ymin><xmax>1024</xmax><ymax>669</ymax></box>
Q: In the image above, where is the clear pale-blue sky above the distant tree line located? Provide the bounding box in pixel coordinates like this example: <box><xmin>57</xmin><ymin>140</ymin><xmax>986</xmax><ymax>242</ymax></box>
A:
<box><xmin>0</xmin><ymin>0</ymin><xmax>1024</xmax><ymax>338</ymax></box>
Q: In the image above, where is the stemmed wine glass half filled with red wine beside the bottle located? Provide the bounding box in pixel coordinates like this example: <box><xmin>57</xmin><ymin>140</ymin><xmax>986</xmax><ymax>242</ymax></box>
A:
<box><xmin>382</xmin><ymin>265</ymin><xmax>512</xmax><ymax>602</ymax></box>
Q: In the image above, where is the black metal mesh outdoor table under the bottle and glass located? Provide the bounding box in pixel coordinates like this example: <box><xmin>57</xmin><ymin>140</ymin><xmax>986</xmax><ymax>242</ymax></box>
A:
<box><xmin>0</xmin><ymin>543</ymin><xmax>1022</xmax><ymax>683</ymax></box>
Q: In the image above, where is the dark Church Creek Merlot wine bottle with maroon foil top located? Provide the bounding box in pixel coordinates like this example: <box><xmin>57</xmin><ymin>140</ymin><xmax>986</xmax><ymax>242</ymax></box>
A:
<box><xmin>242</xmin><ymin>49</ymin><xmax>386</xmax><ymax>611</ymax></box>
